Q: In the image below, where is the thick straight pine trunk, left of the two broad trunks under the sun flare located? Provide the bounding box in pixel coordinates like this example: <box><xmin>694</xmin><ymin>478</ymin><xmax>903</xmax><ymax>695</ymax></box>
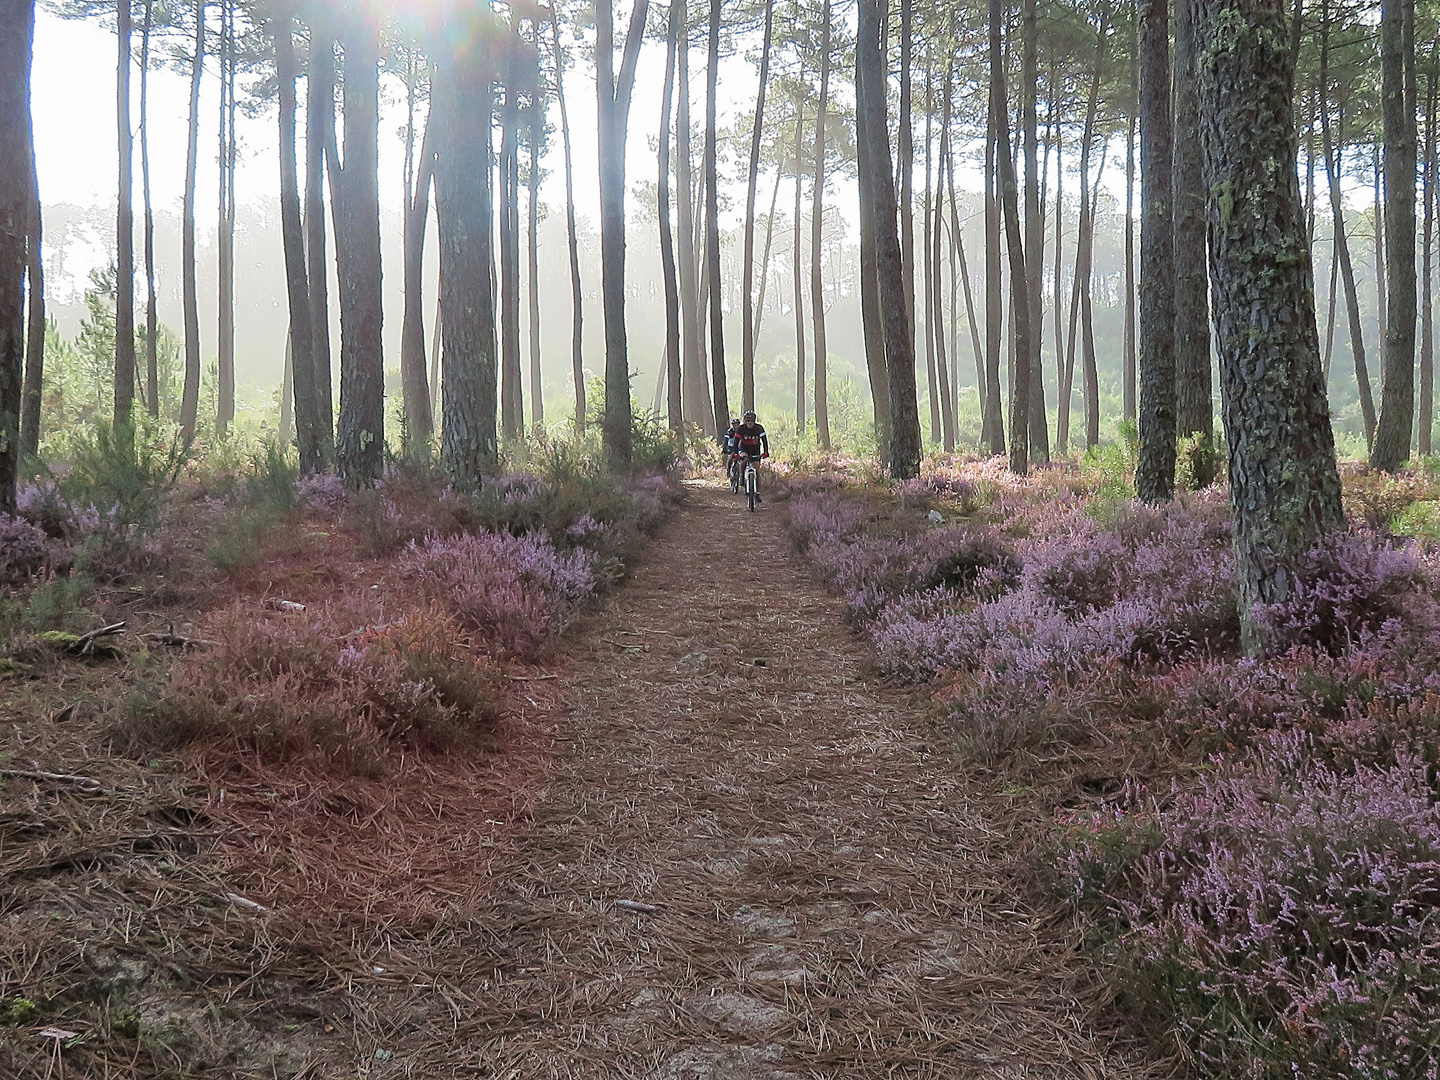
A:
<box><xmin>336</xmin><ymin>16</ymin><xmax>384</xmax><ymax>487</ymax></box>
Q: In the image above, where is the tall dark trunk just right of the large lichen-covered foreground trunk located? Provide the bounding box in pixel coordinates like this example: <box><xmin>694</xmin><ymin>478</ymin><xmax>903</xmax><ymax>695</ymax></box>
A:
<box><xmin>1369</xmin><ymin>0</ymin><xmax>1416</xmax><ymax>472</ymax></box>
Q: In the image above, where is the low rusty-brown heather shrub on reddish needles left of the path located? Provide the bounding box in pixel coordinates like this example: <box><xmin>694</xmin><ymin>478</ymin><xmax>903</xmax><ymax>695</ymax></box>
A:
<box><xmin>117</xmin><ymin>608</ymin><xmax>500</xmax><ymax>776</ymax></box>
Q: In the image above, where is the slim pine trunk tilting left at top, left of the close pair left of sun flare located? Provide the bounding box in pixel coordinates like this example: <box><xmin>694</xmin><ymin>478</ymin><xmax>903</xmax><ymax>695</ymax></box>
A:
<box><xmin>272</xmin><ymin>10</ymin><xmax>327</xmax><ymax>477</ymax></box>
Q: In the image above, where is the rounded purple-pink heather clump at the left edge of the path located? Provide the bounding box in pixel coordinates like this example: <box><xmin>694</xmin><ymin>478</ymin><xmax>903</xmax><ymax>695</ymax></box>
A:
<box><xmin>399</xmin><ymin>533</ymin><xmax>596</xmax><ymax>658</ymax></box>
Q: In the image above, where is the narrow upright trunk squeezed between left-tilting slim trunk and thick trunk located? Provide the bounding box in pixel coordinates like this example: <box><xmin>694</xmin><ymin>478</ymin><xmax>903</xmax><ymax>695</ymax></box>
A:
<box><xmin>305</xmin><ymin>16</ymin><xmax>336</xmax><ymax>457</ymax></box>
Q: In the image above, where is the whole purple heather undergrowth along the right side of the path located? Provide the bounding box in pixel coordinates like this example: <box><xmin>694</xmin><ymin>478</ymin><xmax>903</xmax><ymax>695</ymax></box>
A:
<box><xmin>788</xmin><ymin>446</ymin><xmax>1440</xmax><ymax>1080</ymax></box>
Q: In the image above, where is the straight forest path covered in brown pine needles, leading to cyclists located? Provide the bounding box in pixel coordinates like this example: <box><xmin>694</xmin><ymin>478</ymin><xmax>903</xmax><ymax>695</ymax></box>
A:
<box><xmin>443</xmin><ymin>484</ymin><xmax>1149</xmax><ymax>1080</ymax></box>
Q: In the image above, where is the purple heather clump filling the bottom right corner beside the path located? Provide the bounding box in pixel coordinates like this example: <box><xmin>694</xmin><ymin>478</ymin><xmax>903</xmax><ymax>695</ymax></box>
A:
<box><xmin>1064</xmin><ymin>736</ymin><xmax>1440</xmax><ymax>1079</ymax></box>
